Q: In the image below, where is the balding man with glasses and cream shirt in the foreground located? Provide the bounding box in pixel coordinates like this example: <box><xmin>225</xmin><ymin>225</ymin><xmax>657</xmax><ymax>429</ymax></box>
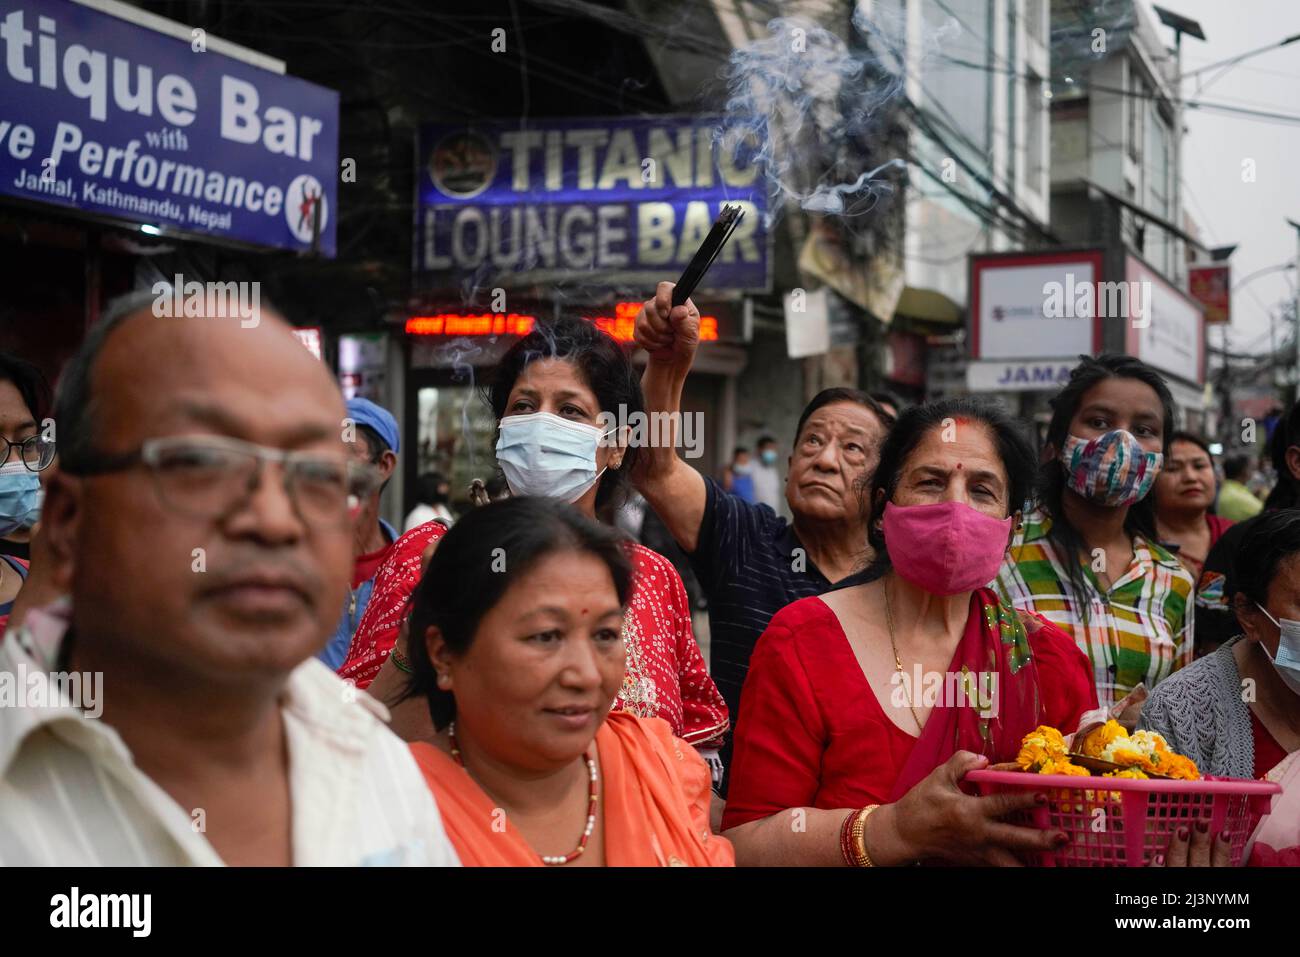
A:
<box><xmin>0</xmin><ymin>293</ymin><xmax>456</xmax><ymax>865</ymax></box>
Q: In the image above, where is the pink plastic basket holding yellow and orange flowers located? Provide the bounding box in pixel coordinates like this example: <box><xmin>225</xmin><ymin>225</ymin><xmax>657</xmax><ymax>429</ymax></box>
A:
<box><xmin>966</xmin><ymin>770</ymin><xmax>1282</xmax><ymax>867</ymax></box>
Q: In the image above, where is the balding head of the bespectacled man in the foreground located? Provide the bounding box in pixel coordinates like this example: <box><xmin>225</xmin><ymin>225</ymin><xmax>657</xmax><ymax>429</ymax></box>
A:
<box><xmin>44</xmin><ymin>289</ymin><xmax>352</xmax><ymax>683</ymax></box>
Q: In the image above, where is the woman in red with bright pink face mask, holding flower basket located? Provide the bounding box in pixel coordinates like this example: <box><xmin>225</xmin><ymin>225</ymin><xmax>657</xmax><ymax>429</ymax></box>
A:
<box><xmin>723</xmin><ymin>398</ymin><xmax>1096</xmax><ymax>866</ymax></box>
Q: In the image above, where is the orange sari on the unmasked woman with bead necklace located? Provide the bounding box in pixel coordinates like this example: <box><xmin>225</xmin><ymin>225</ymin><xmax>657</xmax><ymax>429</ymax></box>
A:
<box><xmin>411</xmin><ymin>711</ymin><xmax>736</xmax><ymax>867</ymax></box>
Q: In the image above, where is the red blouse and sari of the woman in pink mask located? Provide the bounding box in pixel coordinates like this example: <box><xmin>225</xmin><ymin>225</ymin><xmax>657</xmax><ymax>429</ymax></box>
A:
<box><xmin>723</xmin><ymin>588</ymin><xmax>1097</xmax><ymax>828</ymax></box>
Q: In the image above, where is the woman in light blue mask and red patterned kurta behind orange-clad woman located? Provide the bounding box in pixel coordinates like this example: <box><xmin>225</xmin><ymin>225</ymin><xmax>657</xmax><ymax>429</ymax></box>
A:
<box><xmin>339</xmin><ymin>317</ymin><xmax>729</xmax><ymax>771</ymax></box>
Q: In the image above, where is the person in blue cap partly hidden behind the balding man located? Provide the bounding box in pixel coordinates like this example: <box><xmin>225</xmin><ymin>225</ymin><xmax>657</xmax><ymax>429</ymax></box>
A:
<box><xmin>317</xmin><ymin>397</ymin><xmax>400</xmax><ymax>671</ymax></box>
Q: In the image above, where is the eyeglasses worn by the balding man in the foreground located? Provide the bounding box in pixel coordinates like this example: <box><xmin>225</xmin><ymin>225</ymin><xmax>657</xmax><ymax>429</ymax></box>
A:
<box><xmin>60</xmin><ymin>436</ymin><xmax>378</xmax><ymax>525</ymax></box>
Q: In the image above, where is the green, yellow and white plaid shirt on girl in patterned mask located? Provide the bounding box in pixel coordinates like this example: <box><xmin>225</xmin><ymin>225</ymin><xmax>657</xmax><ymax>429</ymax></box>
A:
<box><xmin>996</xmin><ymin>508</ymin><xmax>1195</xmax><ymax>707</ymax></box>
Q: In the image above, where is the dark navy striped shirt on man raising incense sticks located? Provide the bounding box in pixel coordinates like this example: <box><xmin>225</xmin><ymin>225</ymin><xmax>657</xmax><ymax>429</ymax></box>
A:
<box><xmin>690</xmin><ymin>479</ymin><xmax>868</xmax><ymax>752</ymax></box>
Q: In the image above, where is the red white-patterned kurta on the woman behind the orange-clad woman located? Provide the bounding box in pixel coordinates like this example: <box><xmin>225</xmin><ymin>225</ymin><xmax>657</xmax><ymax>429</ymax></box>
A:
<box><xmin>338</xmin><ymin>523</ymin><xmax>728</xmax><ymax>746</ymax></box>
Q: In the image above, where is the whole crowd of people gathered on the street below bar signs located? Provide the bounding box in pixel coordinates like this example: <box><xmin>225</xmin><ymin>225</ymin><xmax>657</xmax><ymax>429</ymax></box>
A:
<box><xmin>0</xmin><ymin>283</ymin><xmax>1300</xmax><ymax>867</ymax></box>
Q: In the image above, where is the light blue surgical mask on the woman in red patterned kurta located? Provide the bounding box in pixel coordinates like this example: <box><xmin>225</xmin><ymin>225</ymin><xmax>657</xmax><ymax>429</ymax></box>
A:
<box><xmin>497</xmin><ymin>412</ymin><xmax>612</xmax><ymax>503</ymax></box>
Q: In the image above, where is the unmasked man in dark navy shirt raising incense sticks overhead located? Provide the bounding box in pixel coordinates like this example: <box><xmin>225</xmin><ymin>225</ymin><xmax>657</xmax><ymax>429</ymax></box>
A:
<box><xmin>636</xmin><ymin>282</ymin><xmax>893</xmax><ymax>759</ymax></box>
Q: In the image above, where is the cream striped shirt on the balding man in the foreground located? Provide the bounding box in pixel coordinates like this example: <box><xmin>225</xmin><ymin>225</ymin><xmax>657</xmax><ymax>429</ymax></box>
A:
<box><xmin>0</xmin><ymin>611</ymin><xmax>459</xmax><ymax>866</ymax></box>
